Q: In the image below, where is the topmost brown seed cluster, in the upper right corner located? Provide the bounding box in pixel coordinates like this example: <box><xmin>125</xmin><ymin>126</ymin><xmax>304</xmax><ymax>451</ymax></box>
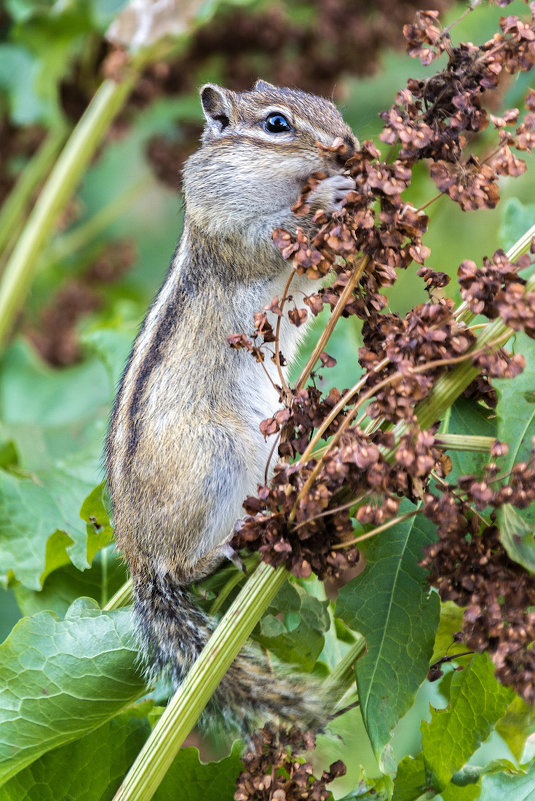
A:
<box><xmin>381</xmin><ymin>4</ymin><xmax>535</xmax><ymax>211</ymax></box>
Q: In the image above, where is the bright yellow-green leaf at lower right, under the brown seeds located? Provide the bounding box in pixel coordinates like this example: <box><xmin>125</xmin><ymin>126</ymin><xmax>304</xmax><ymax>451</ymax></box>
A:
<box><xmin>421</xmin><ymin>654</ymin><xmax>513</xmax><ymax>792</ymax></box>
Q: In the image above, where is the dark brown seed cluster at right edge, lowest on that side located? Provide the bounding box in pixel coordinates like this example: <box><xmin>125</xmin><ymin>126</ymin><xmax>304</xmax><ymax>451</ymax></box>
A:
<box><xmin>422</xmin><ymin>443</ymin><xmax>535</xmax><ymax>703</ymax></box>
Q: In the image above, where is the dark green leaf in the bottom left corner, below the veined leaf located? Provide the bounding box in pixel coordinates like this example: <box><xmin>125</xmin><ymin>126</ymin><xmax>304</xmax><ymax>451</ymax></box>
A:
<box><xmin>2</xmin><ymin>715</ymin><xmax>150</xmax><ymax>801</ymax></box>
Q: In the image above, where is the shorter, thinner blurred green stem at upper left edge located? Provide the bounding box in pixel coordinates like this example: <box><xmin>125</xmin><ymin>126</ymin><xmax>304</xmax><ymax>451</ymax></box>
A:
<box><xmin>0</xmin><ymin>124</ymin><xmax>67</xmax><ymax>264</ymax></box>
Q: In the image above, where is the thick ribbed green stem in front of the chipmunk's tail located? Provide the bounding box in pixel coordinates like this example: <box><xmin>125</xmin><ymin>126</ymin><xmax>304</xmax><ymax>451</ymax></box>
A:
<box><xmin>114</xmin><ymin>563</ymin><xmax>288</xmax><ymax>801</ymax></box>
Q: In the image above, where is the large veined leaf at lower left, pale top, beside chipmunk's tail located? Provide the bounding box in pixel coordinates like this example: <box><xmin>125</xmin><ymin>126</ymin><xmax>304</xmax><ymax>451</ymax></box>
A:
<box><xmin>0</xmin><ymin>599</ymin><xmax>144</xmax><ymax>781</ymax></box>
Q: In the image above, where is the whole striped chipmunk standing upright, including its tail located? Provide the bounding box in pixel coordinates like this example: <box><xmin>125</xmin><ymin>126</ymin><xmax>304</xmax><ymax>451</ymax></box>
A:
<box><xmin>106</xmin><ymin>81</ymin><xmax>357</xmax><ymax>728</ymax></box>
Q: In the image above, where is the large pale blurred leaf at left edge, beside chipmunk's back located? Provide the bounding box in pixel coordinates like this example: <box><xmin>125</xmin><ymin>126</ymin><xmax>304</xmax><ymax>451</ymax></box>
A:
<box><xmin>0</xmin><ymin>342</ymin><xmax>112</xmax><ymax>590</ymax></box>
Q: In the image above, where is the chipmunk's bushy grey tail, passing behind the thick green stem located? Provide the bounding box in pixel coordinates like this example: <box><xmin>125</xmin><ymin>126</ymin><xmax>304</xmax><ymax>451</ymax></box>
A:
<box><xmin>134</xmin><ymin>575</ymin><xmax>332</xmax><ymax>732</ymax></box>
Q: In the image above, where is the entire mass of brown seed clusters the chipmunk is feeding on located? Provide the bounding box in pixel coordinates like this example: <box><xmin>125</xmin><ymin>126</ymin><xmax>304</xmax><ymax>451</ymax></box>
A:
<box><xmin>230</xmin><ymin>6</ymin><xmax>535</xmax><ymax>698</ymax></box>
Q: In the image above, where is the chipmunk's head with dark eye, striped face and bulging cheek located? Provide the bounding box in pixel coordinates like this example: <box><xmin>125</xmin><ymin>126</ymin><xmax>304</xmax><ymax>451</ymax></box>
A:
<box><xmin>184</xmin><ymin>81</ymin><xmax>358</xmax><ymax>238</ymax></box>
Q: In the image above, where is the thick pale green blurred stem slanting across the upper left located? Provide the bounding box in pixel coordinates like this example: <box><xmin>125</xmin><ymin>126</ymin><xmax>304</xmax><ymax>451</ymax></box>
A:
<box><xmin>0</xmin><ymin>70</ymin><xmax>137</xmax><ymax>349</ymax></box>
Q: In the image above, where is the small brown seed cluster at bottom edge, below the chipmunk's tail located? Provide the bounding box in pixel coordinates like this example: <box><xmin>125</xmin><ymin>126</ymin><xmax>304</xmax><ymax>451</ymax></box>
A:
<box><xmin>234</xmin><ymin>723</ymin><xmax>346</xmax><ymax>801</ymax></box>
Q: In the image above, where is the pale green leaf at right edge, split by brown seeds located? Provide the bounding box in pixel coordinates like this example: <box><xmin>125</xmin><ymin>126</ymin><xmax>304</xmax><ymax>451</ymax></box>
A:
<box><xmin>493</xmin><ymin>332</ymin><xmax>535</xmax><ymax>571</ymax></box>
